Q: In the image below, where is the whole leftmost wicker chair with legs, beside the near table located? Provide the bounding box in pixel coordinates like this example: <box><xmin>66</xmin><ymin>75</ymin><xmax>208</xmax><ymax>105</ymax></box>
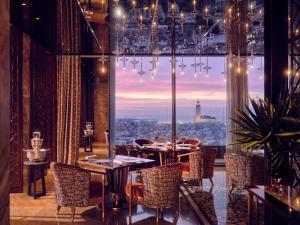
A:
<box><xmin>50</xmin><ymin>162</ymin><xmax>105</xmax><ymax>222</ymax></box>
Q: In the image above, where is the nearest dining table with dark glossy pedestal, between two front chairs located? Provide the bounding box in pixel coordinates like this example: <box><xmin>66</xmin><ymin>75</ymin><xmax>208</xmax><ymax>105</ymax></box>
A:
<box><xmin>77</xmin><ymin>155</ymin><xmax>155</xmax><ymax>209</ymax></box>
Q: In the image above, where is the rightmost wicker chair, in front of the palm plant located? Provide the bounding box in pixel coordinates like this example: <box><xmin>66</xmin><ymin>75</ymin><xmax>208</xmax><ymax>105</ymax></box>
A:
<box><xmin>224</xmin><ymin>153</ymin><xmax>264</xmax><ymax>194</ymax></box>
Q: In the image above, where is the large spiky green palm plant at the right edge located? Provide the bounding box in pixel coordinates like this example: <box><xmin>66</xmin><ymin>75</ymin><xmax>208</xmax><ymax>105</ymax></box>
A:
<box><xmin>232</xmin><ymin>82</ymin><xmax>300</xmax><ymax>184</ymax></box>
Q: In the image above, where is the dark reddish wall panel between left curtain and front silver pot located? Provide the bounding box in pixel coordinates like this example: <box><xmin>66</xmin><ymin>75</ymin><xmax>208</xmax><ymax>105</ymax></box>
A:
<box><xmin>30</xmin><ymin>42</ymin><xmax>57</xmax><ymax>161</ymax></box>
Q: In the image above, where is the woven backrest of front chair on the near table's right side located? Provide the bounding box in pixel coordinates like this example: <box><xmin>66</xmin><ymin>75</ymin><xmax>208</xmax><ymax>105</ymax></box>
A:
<box><xmin>142</xmin><ymin>163</ymin><xmax>182</xmax><ymax>208</ymax></box>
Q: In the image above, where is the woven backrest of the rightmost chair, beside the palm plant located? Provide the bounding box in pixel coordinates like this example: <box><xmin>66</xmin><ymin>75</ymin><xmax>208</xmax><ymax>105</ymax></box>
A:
<box><xmin>224</xmin><ymin>153</ymin><xmax>254</xmax><ymax>189</ymax></box>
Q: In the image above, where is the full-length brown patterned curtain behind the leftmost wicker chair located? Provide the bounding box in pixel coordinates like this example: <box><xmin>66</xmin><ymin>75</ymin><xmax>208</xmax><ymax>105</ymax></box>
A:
<box><xmin>57</xmin><ymin>55</ymin><xmax>81</xmax><ymax>164</ymax></box>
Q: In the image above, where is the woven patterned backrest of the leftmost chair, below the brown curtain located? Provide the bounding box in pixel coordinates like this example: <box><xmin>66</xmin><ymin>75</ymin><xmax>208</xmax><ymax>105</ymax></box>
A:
<box><xmin>50</xmin><ymin>162</ymin><xmax>90</xmax><ymax>207</ymax></box>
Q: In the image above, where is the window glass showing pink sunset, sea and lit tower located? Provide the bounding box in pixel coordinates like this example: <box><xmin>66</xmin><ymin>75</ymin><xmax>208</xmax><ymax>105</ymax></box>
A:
<box><xmin>115</xmin><ymin>56</ymin><xmax>264</xmax><ymax>146</ymax></box>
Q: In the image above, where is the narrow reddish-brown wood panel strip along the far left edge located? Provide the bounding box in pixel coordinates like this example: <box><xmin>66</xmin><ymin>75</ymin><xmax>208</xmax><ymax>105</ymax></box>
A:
<box><xmin>0</xmin><ymin>0</ymin><xmax>10</xmax><ymax>221</ymax></box>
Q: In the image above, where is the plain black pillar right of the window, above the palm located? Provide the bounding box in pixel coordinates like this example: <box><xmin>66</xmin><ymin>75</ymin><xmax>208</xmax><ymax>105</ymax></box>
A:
<box><xmin>264</xmin><ymin>0</ymin><xmax>288</xmax><ymax>103</ymax></box>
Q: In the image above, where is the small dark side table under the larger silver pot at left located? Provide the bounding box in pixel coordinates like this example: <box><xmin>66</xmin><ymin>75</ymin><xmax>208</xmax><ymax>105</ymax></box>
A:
<box><xmin>24</xmin><ymin>161</ymin><xmax>48</xmax><ymax>199</ymax></box>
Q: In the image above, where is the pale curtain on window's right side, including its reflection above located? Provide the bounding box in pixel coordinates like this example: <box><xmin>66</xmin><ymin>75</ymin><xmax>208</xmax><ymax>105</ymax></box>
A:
<box><xmin>225</xmin><ymin>0</ymin><xmax>250</xmax><ymax>150</ymax></box>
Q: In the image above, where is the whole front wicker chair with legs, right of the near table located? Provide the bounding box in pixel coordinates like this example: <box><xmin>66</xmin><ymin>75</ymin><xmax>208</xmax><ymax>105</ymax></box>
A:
<box><xmin>126</xmin><ymin>163</ymin><xmax>182</xmax><ymax>223</ymax></box>
